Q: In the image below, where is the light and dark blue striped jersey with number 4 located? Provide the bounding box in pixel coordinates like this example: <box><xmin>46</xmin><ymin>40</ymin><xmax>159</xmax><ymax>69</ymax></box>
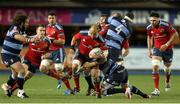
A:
<box><xmin>105</xmin><ymin>17</ymin><xmax>132</xmax><ymax>49</ymax></box>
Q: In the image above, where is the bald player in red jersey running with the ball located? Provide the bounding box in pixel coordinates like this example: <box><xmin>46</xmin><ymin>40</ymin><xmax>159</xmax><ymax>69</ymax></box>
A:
<box><xmin>70</xmin><ymin>25</ymin><xmax>104</xmax><ymax>95</ymax></box>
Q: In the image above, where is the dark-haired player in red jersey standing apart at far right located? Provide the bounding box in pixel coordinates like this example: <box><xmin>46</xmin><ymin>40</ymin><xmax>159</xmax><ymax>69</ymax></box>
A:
<box><xmin>147</xmin><ymin>12</ymin><xmax>178</xmax><ymax>96</ymax></box>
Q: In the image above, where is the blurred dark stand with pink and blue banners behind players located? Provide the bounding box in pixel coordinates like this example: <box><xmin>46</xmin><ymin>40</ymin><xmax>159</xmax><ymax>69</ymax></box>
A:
<box><xmin>0</xmin><ymin>0</ymin><xmax>180</xmax><ymax>47</ymax></box>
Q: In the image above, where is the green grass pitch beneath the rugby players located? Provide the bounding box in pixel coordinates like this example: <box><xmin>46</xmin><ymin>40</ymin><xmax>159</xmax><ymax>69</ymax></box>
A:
<box><xmin>0</xmin><ymin>74</ymin><xmax>180</xmax><ymax>103</ymax></box>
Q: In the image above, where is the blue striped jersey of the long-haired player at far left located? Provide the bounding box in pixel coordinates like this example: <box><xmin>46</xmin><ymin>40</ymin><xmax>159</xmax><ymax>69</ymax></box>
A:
<box><xmin>1</xmin><ymin>26</ymin><xmax>26</xmax><ymax>55</ymax></box>
